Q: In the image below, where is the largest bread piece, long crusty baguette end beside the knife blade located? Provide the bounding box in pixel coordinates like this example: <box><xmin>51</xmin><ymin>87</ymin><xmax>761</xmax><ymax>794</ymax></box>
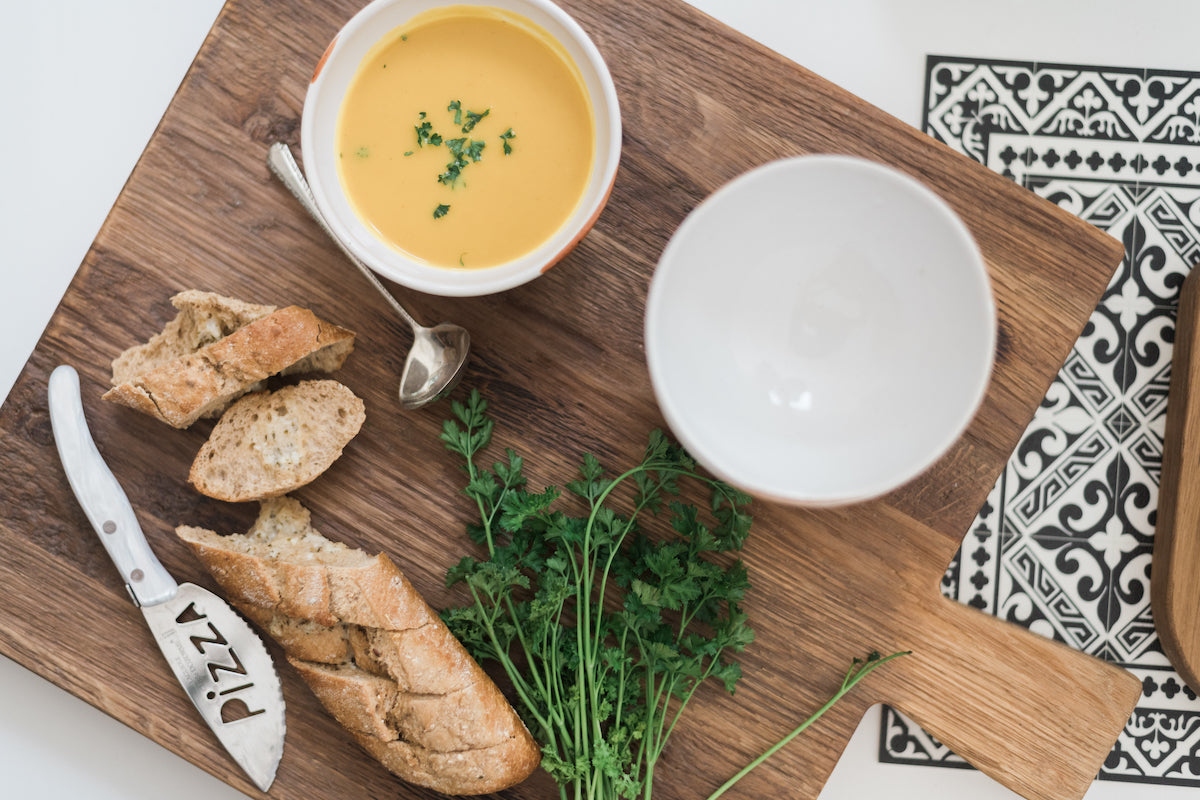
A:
<box><xmin>176</xmin><ymin>498</ymin><xmax>541</xmax><ymax>794</ymax></box>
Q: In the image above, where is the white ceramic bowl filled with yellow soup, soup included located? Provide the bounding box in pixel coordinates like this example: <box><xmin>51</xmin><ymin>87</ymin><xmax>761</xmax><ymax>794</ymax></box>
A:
<box><xmin>300</xmin><ymin>0</ymin><xmax>620</xmax><ymax>296</ymax></box>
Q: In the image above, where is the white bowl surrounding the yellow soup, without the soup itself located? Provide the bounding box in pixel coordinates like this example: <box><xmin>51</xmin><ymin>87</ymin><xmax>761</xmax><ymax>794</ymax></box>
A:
<box><xmin>300</xmin><ymin>0</ymin><xmax>620</xmax><ymax>296</ymax></box>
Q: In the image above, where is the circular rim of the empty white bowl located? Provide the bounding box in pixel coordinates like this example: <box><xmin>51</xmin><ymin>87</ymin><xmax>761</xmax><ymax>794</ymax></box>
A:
<box><xmin>643</xmin><ymin>154</ymin><xmax>997</xmax><ymax>507</ymax></box>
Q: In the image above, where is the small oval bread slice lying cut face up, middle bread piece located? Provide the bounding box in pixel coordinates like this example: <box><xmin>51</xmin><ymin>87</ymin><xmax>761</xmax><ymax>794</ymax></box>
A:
<box><xmin>188</xmin><ymin>380</ymin><xmax>366</xmax><ymax>503</ymax></box>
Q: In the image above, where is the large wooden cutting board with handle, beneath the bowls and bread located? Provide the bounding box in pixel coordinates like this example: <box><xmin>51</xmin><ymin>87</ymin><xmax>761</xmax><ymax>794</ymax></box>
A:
<box><xmin>0</xmin><ymin>0</ymin><xmax>1139</xmax><ymax>800</ymax></box>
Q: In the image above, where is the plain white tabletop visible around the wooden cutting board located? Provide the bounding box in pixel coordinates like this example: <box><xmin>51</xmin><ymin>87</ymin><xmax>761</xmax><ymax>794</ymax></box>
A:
<box><xmin>0</xmin><ymin>0</ymin><xmax>1200</xmax><ymax>800</ymax></box>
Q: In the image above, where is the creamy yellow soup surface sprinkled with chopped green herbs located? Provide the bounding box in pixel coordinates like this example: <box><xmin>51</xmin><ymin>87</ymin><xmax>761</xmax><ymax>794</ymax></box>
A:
<box><xmin>337</xmin><ymin>6</ymin><xmax>595</xmax><ymax>269</ymax></box>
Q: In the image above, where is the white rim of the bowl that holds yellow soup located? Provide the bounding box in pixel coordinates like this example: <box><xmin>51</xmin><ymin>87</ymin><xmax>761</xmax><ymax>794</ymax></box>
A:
<box><xmin>300</xmin><ymin>0</ymin><xmax>622</xmax><ymax>296</ymax></box>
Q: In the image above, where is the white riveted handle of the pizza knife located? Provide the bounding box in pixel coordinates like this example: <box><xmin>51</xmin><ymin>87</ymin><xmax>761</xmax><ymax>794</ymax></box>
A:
<box><xmin>49</xmin><ymin>366</ymin><xmax>179</xmax><ymax>606</ymax></box>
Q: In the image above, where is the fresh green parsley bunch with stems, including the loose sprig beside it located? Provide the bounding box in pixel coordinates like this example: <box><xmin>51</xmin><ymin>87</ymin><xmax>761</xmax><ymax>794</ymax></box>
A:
<box><xmin>442</xmin><ymin>391</ymin><xmax>899</xmax><ymax>800</ymax></box>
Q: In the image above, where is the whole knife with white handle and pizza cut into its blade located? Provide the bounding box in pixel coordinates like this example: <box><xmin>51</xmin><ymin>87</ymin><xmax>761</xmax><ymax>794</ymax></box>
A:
<box><xmin>48</xmin><ymin>365</ymin><xmax>286</xmax><ymax>792</ymax></box>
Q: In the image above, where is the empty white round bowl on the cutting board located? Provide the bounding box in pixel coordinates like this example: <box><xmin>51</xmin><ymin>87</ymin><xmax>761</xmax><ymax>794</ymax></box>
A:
<box><xmin>646</xmin><ymin>156</ymin><xmax>996</xmax><ymax>505</ymax></box>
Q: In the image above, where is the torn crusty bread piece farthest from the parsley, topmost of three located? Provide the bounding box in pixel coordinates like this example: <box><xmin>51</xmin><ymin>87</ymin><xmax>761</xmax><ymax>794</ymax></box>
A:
<box><xmin>104</xmin><ymin>289</ymin><xmax>354</xmax><ymax>428</ymax></box>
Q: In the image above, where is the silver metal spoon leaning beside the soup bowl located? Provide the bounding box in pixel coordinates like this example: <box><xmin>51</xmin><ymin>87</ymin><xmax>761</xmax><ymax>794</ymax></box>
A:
<box><xmin>266</xmin><ymin>142</ymin><xmax>470</xmax><ymax>410</ymax></box>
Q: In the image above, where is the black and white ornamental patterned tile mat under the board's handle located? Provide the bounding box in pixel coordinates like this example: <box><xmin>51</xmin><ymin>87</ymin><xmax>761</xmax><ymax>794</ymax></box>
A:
<box><xmin>880</xmin><ymin>56</ymin><xmax>1200</xmax><ymax>786</ymax></box>
